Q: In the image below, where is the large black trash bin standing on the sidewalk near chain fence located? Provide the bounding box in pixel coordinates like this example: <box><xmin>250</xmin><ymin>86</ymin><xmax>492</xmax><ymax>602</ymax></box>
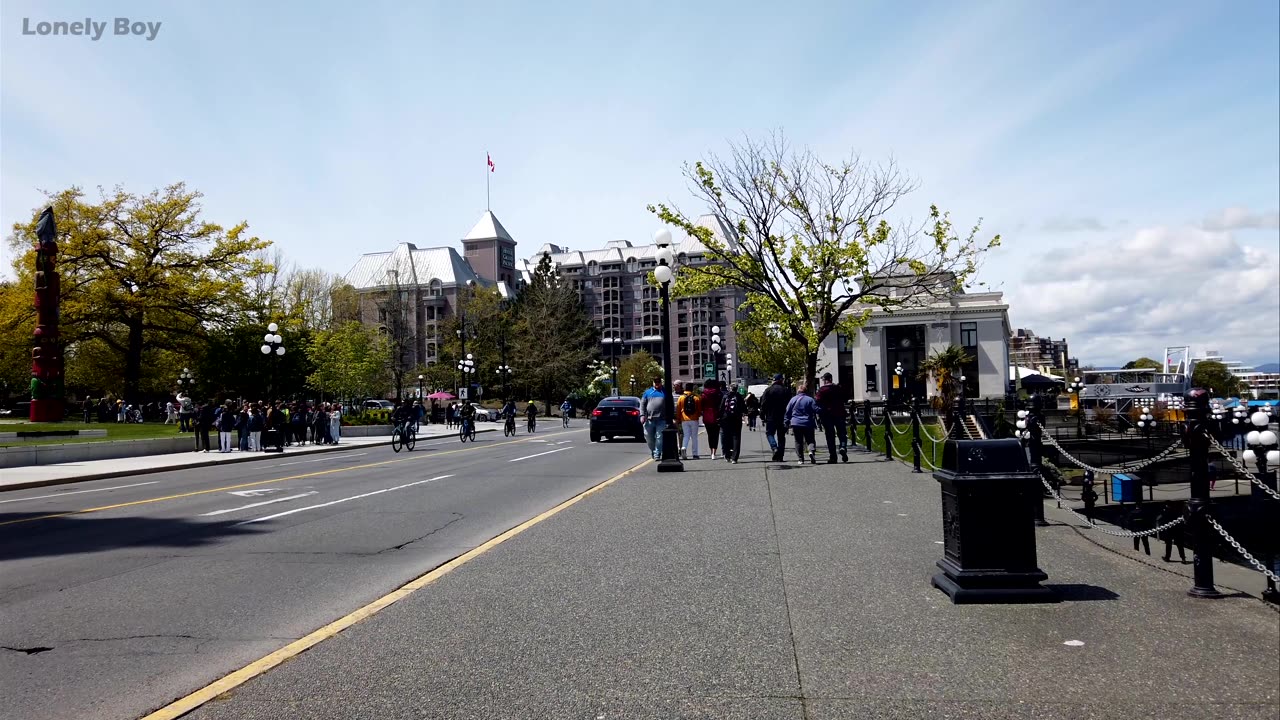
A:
<box><xmin>932</xmin><ymin>439</ymin><xmax>1059</xmax><ymax>605</ymax></box>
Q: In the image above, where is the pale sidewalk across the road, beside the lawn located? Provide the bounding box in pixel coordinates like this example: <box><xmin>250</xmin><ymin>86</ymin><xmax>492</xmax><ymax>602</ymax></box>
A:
<box><xmin>0</xmin><ymin>425</ymin><xmax>497</xmax><ymax>492</ymax></box>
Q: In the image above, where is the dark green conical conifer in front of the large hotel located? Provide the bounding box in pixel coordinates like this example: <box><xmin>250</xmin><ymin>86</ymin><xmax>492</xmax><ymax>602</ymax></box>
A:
<box><xmin>511</xmin><ymin>255</ymin><xmax>599</xmax><ymax>409</ymax></box>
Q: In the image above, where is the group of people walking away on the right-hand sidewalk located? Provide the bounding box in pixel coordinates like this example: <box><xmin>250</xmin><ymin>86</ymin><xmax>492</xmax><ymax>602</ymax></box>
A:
<box><xmin>640</xmin><ymin>373</ymin><xmax>849</xmax><ymax>464</ymax></box>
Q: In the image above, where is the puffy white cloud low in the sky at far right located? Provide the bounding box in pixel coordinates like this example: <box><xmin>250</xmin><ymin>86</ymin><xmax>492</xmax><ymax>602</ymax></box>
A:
<box><xmin>1007</xmin><ymin>225</ymin><xmax>1280</xmax><ymax>365</ymax></box>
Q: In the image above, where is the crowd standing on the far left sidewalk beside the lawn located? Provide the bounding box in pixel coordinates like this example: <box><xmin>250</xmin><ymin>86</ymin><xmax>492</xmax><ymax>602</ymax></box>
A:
<box><xmin>177</xmin><ymin>396</ymin><xmax>343</xmax><ymax>452</ymax></box>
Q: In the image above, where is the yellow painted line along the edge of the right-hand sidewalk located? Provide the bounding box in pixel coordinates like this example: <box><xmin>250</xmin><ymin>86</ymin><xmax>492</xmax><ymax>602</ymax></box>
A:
<box><xmin>142</xmin><ymin>459</ymin><xmax>653</xmax><ymax>720</ymax></box>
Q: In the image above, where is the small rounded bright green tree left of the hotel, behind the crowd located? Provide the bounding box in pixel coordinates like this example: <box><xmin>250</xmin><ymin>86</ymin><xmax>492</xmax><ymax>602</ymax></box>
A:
<box><xmin>307</xmin><ymin>320</ymin><xmax>393</xmax><ymax>400</ymax></box>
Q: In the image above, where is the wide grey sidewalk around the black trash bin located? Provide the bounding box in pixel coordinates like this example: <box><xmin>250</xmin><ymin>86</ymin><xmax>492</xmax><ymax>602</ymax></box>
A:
<box><xmin>189</xmin><ymin>437</ymin><xmax>1280</xmax><ymax>720</ymax></box>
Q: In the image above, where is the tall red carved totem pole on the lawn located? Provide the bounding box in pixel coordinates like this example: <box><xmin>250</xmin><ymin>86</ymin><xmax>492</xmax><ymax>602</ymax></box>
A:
<box><xmin>31</xmin><ymin>208</ymin><xmax>67</xmax><ymax>423</ymax></box>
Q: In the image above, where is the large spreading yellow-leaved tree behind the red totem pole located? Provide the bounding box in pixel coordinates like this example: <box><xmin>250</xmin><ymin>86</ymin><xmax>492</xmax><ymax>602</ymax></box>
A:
<box><xmin>0</xmin><ymin>183</ymin><xmax>269</xmax><ymax>401</ymax></box>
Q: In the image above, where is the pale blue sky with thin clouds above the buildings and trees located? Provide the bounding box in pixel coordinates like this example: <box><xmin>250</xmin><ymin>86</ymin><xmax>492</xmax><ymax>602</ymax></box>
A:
<box><xmin>0</xmin><ymin>0</ymin><xmax>1280</xmax><ymax>366</ymax></box>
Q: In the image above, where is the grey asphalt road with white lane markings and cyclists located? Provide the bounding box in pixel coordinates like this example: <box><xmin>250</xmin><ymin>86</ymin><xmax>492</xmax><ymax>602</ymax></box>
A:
<box><xmin>0</xmin><ymin>420</ymin><xmax>648</xmax><ymax>720</ymax></box>
